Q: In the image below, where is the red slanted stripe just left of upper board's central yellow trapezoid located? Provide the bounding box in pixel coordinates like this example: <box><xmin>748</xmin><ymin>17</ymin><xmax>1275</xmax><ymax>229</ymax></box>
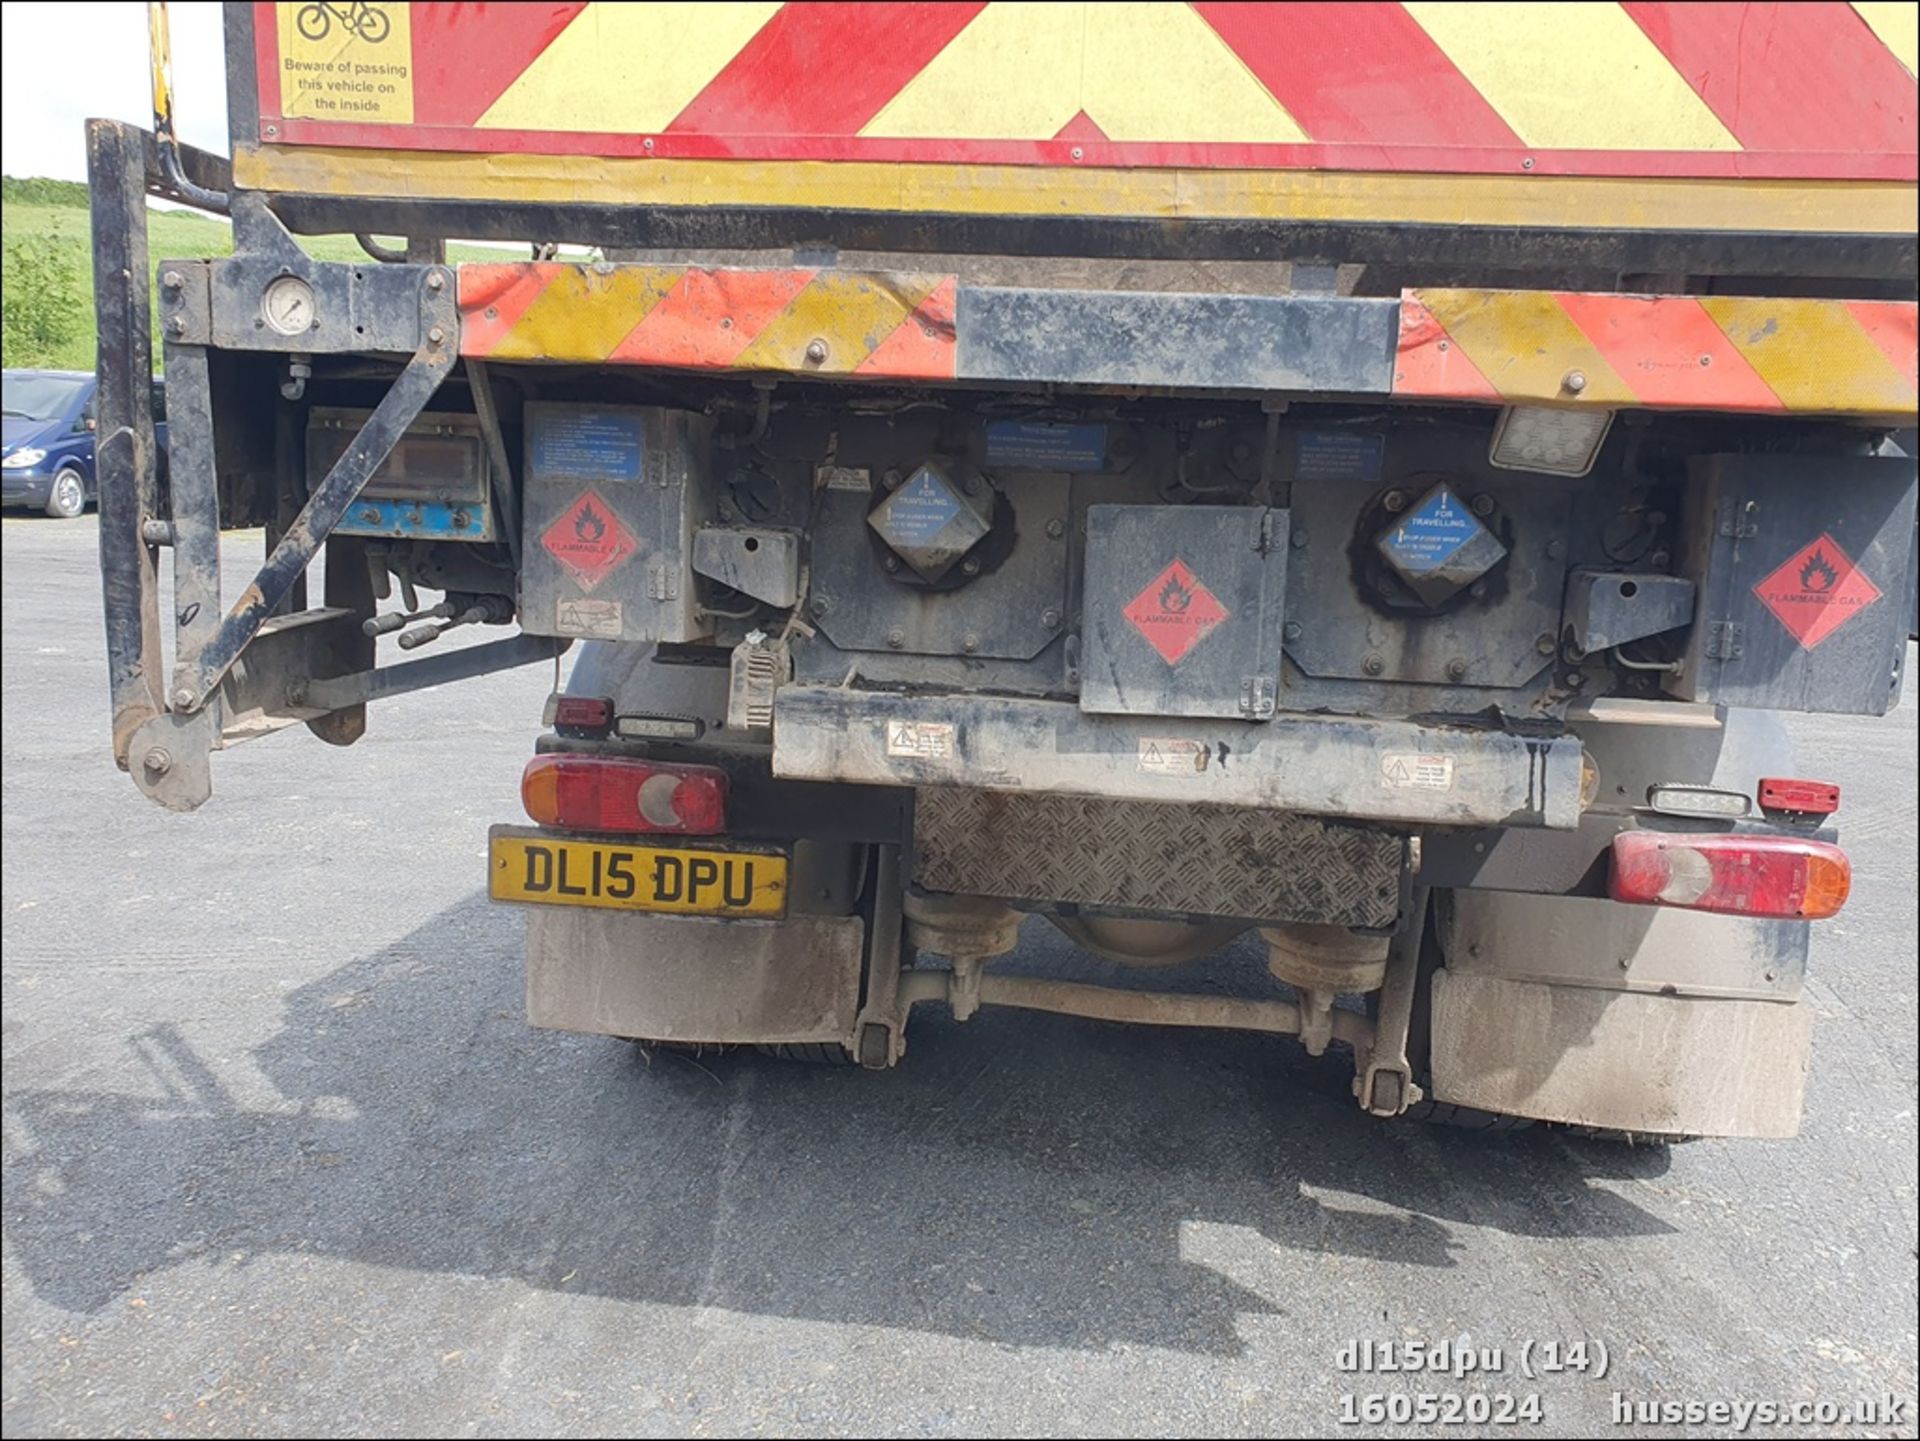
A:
<box><xmin>668</xmin><ymin>4</ymin><xmax>987</xmax><ymax>136</ymax></box>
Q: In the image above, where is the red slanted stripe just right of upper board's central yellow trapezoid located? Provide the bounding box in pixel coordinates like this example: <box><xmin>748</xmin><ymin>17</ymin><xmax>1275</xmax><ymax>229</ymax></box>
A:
<box><xmin>1194</xmin><ymin>0</ymin><xmax>1521</xmax><ymax>146</ymax></box>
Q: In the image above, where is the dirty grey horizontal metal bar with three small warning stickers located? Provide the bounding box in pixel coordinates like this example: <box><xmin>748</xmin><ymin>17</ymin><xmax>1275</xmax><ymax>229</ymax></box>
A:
<box><xmin>774</xmin><ymin>685</ymin><xmax>1584</xmax><ymax>831</ymax></box>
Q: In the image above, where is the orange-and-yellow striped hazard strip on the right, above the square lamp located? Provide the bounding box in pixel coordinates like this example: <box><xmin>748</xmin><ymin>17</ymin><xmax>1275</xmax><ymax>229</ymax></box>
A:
<box><xmin>1394</xmin><ymin>290</ymin><xmax>1916</xmax><ymax>416</ymax></box>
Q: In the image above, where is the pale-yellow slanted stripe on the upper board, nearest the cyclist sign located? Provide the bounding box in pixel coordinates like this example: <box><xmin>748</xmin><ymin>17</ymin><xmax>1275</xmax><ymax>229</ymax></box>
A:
<box><xmin>480</xmin><ymin>0</ymin><xmax>780</xmax><ymax>132</ymax></box>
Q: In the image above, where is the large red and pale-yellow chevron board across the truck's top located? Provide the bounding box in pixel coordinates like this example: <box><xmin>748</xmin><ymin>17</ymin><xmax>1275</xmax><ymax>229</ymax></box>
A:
<box><xmin>247</xmin><ymin>0</ymin><xmax>1920</xmax><ymax>210</ymax></box>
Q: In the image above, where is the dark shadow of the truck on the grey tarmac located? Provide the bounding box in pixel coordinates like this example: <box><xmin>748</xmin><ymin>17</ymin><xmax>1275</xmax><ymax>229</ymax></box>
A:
<box><xmin>6</xmin><ymin>896</ymin><xmax>1670</xmax><ymax>1355</ymax></box>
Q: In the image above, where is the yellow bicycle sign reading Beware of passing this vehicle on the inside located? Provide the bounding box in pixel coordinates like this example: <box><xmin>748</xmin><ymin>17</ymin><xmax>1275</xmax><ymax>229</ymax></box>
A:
<box><xmin>273</xmin><ymin>0</ymin><xmax>413</xmax><ymax>125</ymax></box>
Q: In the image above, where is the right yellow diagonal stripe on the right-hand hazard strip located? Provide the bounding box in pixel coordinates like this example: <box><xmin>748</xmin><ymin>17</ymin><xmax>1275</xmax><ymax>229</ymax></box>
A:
<box><xmin>1699</xmin><ymin>295</ymin><xmax>1914</xmax><ymax>414</ymax></box>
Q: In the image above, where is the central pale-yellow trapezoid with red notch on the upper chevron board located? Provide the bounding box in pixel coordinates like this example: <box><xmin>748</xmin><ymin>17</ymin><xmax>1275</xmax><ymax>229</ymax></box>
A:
<box><xmin>860</xmin><ymin>0</ymin><xmax>1308</xmax><ymax>144</ymax></box>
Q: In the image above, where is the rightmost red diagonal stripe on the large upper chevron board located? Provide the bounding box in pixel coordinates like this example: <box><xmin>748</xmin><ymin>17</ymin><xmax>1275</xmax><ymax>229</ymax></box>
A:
<box><xmin>1622</xmin><ymin>2</ymin><xmax>1920</xmax><ymax>152</ymax></box>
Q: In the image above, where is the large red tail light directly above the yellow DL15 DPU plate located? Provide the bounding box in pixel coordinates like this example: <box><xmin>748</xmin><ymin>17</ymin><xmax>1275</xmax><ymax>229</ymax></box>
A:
<box><xmin>520</xmin><ymin>756</ymin><xmax>726</xmax><ymax>835</ymax></box>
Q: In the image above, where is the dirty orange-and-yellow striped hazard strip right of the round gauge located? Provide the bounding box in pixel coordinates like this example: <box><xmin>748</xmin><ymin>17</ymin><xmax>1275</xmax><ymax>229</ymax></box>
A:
<box><xmin>459</xmin><ymin>261</ymin><xmax>954</xmax><ymax>380</ymax></box>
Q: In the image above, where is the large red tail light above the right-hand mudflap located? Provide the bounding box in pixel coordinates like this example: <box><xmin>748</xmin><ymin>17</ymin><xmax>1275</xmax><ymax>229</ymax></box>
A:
<box><xmin>1607</xmin><ymin>831</ymin><xmax>1853</xmax><ymax>921</ymax></box>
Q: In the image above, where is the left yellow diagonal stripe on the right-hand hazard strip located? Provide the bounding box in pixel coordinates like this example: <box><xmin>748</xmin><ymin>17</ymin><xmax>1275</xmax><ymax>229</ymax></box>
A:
<box><xmin>1419</xmin><ymin>290</ymin><xmax>1638</xmax><ymax>405</ymax></box>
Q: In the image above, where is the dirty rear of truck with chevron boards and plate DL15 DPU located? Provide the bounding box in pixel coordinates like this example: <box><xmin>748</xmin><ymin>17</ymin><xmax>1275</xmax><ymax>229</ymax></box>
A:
<box><xmin>88</xmin><ymin>2</ymin><xmax>1916</xmax><ymax>1138</ymax></box>
